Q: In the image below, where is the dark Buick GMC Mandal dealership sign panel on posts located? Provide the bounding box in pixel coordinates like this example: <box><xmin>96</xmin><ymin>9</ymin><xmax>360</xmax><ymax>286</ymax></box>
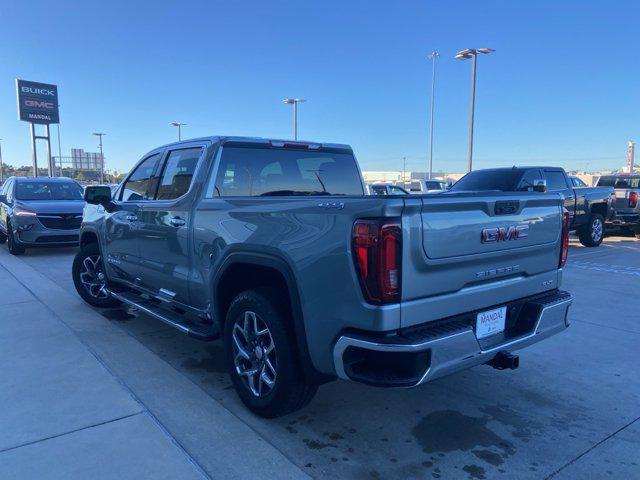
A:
<box><xmin>16</xmin><ymin>79</ymin><xmax>60</xmax><ymax>124</ymax></box>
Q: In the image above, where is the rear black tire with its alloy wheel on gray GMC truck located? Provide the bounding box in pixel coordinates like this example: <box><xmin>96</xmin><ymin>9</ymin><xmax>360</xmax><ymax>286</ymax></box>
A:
<box><xmin>224</xmin><ymin>289</ymin><xmax>318</xmax><ymax>418</ymax></box>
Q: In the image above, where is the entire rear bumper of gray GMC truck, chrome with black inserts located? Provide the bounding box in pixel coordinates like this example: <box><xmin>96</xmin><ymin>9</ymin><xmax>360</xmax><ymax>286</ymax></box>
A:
<box><xmin>333</xmin><ymin>290</ymin><xmax>573</xmax><ymax>387</ymax></box>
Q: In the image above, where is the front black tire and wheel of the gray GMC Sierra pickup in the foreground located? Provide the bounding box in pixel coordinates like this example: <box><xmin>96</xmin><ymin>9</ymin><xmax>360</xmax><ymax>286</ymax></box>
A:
<box><xmin>71</xmin><ymin>243</ymin><xmax>120</xmax><ymax>308</ymax></box>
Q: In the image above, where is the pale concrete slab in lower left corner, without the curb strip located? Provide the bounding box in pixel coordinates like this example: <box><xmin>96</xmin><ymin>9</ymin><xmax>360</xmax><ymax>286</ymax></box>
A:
<box><xmin>0</xmin><ymin>265</ymin><xmax>204</xmax><ymax>480</ymax></box>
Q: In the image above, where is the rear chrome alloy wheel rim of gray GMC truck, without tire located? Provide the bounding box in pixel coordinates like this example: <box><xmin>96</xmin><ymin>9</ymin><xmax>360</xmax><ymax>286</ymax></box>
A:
<box><xmin>231</xmin><ymin>311</ymin><xmax>278</xmax><ymax>398</ymax></box>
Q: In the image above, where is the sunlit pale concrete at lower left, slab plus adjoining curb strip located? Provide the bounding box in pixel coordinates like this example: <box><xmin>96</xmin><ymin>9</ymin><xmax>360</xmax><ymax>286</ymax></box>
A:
<box><xmin>0</xmin><ymin>249</ymin><xmax>304</xmax><ymax>480</ymax></box>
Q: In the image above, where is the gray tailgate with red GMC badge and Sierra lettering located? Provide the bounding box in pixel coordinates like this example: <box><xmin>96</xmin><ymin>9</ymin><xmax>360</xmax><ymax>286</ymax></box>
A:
<box><xmin>401</xmin><ymin>192</ymin><xmax>562</xmax><ymax>327</ymax></box>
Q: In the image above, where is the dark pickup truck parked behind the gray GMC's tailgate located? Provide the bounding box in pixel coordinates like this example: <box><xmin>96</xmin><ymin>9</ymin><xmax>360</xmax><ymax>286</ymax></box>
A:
<box><xmin>449</xmin><ymin>167</ymin><xmax>615</xmax><ymax>247</ymax></box>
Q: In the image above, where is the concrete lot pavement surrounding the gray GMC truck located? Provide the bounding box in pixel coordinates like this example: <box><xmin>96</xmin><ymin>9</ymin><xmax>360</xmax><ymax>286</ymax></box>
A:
<box><xmin>0</xmin><ymin>234</ymin><xmax>640</xmax><ymax>479</ymax></box>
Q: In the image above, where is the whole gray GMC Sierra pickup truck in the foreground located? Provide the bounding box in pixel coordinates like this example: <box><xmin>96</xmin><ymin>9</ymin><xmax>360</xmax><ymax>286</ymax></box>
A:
<box><xmin>73</xmin><ymin>137</ymin><xmax>571</xmax><ymax>417</ymax></box>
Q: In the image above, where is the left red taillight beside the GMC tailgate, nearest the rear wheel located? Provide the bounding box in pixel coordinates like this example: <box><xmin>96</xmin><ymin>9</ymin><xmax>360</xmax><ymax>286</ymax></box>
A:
<box><xmin>353</xmin><ymin>219</ymin><xmax>402</xmax><ymax>304</ymax></box>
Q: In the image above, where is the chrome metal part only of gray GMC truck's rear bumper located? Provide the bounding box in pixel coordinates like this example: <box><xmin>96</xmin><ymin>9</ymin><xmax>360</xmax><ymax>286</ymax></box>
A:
<box><xmin>333</xmin><ymin>291</ymin><xmax>573</xmax><ymax>387</ymax></box>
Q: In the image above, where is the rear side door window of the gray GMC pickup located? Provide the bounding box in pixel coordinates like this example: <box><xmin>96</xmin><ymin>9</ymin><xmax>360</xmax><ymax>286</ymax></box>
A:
<box><xmin>155</xmin><ymin>147</ymin><xmax>202</xmax><ymax>200</ymax></box>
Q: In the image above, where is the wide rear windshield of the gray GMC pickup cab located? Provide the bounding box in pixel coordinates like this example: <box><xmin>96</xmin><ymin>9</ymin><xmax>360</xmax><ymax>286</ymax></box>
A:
<box><xmin>207</xmin><ymin>146</ymin><xmax>364</xmax><ymax>197</ymax></box>
